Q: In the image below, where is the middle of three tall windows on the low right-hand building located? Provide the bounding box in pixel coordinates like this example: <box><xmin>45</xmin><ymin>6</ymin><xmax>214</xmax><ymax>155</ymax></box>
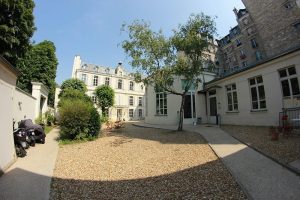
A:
<box><xmin>249</xmin><ymin>76</ymin><xmax>266</xmax><ymax>110</ymax></box>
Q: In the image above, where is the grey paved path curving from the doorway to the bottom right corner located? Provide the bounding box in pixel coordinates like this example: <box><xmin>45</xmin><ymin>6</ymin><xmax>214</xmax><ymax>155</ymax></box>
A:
<box><xmin>135</xmin><ymin>122</ymin><xmax>300</xmax><ymax>200</ymax></box>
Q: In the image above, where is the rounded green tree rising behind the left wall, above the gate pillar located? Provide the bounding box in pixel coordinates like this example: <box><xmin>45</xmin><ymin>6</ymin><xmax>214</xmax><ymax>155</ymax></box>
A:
<box><xmin>17</xmin><ymin>40</ymin><xmax>58</xmax><ymax>106</ymax></box>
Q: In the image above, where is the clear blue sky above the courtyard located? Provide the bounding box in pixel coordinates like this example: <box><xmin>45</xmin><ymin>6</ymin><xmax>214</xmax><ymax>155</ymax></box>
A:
<box><xmin>32</xmin><ymin>0</ymin><xmax>244</xmax><ymax>84</ymax></box>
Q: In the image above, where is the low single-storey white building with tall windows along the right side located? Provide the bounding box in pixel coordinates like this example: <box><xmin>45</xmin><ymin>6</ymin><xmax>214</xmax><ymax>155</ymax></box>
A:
<box><xmin>202</xmin><ymin>47</ymin><xmax>300</xmax><ymax>126</ymax></box>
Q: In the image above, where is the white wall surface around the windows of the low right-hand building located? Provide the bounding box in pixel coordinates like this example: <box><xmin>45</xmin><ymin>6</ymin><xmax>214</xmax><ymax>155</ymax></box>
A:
<box><xmin>207</xmin><ymin>51</ymin><xmax>300</xmax><ymax>126</ymax></box>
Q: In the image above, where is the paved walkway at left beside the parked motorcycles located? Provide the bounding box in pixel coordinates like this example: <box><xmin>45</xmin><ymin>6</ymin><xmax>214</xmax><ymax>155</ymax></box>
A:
<box><xmin>0</xmin><ymin>129</ymin><xmax>58</xmax><ymax>200</ymax></box>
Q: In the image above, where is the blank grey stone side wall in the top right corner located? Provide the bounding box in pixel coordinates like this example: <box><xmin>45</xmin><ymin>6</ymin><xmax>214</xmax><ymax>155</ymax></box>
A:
<box><xmin>242</xmin><ymin>0</ymin><xmax>300</xmax><ymax>57</ymax></box>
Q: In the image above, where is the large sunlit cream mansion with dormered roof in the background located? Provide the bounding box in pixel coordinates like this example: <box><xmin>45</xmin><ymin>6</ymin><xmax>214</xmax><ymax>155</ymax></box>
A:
<box><xmin>72</xmin><ymin>56</ymin><xmax>145</xmax><ymax>120</ymax></box>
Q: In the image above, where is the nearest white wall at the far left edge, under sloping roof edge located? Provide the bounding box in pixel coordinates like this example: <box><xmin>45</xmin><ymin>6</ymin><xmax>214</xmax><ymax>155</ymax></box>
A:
<box><xmin>0</xmin><ymin>59</ymin><xmax>17</xmax><ymax>174</ymax></box>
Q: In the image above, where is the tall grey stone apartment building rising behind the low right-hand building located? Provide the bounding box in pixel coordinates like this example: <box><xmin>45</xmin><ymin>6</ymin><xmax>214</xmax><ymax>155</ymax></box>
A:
<box><xmin>217</xmin><ymin>0</ymin><xmax>300</xmax><ymax>76</ymax></box>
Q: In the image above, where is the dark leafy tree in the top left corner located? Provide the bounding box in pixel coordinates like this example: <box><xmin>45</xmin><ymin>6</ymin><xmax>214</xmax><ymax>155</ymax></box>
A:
<box><xmin>0</xmin><ymin>0</ymin><xmax>35</xmax><ymax>66</ymax></box>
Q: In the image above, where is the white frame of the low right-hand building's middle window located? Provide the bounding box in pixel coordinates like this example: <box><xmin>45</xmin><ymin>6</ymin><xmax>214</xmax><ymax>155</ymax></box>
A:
<box><xmin>248</xmin><ymin>75</ymin><xmax>267</xmax><ymax>111</ymax></box>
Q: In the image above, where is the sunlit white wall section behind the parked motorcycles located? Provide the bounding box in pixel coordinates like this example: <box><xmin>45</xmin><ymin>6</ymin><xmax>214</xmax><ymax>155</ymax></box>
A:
<box><xmin>13</xmin><ymin>88</ymin><xmax>36</xmax><ymax>124</ymax></box>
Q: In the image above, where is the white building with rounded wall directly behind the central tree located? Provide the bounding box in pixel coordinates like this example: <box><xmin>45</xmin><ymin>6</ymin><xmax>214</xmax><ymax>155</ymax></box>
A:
<box><xmin>145</xmin><ymin>72</ymin><xmax>215</xmax><ymax>125</ymax></box>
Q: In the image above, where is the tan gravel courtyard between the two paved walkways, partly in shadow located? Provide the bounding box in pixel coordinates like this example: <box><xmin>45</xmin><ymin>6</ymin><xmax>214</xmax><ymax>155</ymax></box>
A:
<box><xmin>50</xmin><ymin>124</ymin><xmax>246</xmax><ymax>199</ymax></box>
